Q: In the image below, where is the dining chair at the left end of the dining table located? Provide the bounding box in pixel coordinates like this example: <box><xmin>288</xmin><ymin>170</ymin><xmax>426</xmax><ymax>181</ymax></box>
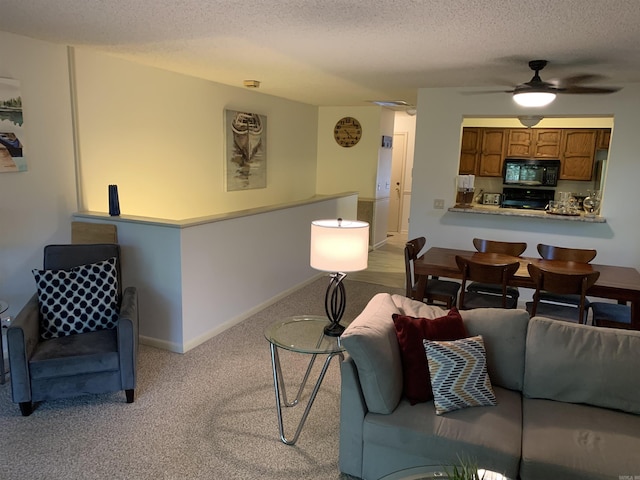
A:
<box><xmin>404</xmin><ymin>237</ymin><xmax>460</xmax><ymax>308</ymax></box>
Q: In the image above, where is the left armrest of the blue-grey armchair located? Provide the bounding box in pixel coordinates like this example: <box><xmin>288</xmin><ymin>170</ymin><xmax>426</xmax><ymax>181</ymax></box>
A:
<box><xmin>7</xmin><ymin>294</ymin><xmax>40</xmax><ymax>403</ymax></box>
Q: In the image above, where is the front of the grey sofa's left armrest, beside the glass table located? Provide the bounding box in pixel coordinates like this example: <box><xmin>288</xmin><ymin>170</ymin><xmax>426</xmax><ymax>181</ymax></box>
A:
<box><xmin>339</xmin><ymin>355</ymin><xmax>368</xmax><ymax>478</ymax></box>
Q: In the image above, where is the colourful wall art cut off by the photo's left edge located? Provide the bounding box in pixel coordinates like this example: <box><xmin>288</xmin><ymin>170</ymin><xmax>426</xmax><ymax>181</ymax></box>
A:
<box><xmin>0</xmin><ymin>78</ymin><xmax>27</xmax><ymax>173</ymax></box>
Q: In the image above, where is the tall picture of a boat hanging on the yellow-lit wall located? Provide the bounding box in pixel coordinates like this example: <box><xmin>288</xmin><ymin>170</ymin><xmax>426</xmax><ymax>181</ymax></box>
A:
<box><xmin>224</xmin><ymin>110</ymin><xmax>267</xmax><ymax>192</ymax></box>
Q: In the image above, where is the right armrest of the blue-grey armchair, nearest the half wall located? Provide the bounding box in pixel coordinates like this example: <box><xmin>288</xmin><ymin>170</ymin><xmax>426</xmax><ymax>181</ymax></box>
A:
<box><xmin>116</xmin><ymin>287</ymin><xmax>139</xmax><ymax>390</ymax></box>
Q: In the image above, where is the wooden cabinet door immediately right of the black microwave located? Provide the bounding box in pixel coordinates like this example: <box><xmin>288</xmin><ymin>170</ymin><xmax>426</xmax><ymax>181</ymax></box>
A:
<box><xmin>560</xmin><ymin>129</ymin><xmax>598</xmax><ymax>180</ymax></box>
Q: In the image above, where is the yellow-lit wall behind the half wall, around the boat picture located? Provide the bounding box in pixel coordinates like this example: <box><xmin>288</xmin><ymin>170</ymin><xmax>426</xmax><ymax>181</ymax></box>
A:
<box><xmin>75</xmin><ymin>49</ymin><xmax>320</xmax><ymax>220</ymax></box>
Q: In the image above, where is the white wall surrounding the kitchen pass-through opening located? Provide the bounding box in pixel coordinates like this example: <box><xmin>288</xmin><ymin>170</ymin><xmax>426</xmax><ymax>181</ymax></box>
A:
<box><xmin>409</xmin><ymin>84</ymin><xmax>640</xmax><ymax>268</ymax></box>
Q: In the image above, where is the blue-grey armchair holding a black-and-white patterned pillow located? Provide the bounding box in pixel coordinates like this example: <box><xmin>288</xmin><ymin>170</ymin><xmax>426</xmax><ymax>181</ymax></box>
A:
<box><xmin>7</xmin><ymin>244</ymin><xmax>138</xmax><ymax>416</ymax></box>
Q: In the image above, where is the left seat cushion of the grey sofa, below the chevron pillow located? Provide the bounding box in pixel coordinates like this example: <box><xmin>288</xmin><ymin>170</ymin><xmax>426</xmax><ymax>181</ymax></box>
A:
<box><xmin>362</xmin><ymin>387</ymin><xmax>522</xmax><ymax>478</ymax></box>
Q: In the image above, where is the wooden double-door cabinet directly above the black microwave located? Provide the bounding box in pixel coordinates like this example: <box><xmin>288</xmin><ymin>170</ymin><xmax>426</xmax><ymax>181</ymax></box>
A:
<box><xmin>507</xmin><ymin>128</ymin><xmax>562</xmax><ymax>159</ymax></box>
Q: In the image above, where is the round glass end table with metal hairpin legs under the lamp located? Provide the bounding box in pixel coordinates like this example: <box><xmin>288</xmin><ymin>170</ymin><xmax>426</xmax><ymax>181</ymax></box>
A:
<box><xmin>264</xmin><ymin>315</ymin><xmax>344</xmax><ymax>445</ymax></box>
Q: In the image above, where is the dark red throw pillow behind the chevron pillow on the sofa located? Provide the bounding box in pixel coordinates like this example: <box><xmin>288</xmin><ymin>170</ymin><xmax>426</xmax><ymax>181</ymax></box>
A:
<box><xmin>393</xmin><ymin>307</ymin><xmax>469</xmax><ymax>405</ymax></box>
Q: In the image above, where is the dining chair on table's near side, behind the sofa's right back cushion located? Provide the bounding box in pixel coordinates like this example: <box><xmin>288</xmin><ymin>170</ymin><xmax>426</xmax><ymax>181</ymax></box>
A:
<box><xmin>526</xmin><ymin>263</ymin><xmax>600</xmax><ymax>324</ymax></box>
